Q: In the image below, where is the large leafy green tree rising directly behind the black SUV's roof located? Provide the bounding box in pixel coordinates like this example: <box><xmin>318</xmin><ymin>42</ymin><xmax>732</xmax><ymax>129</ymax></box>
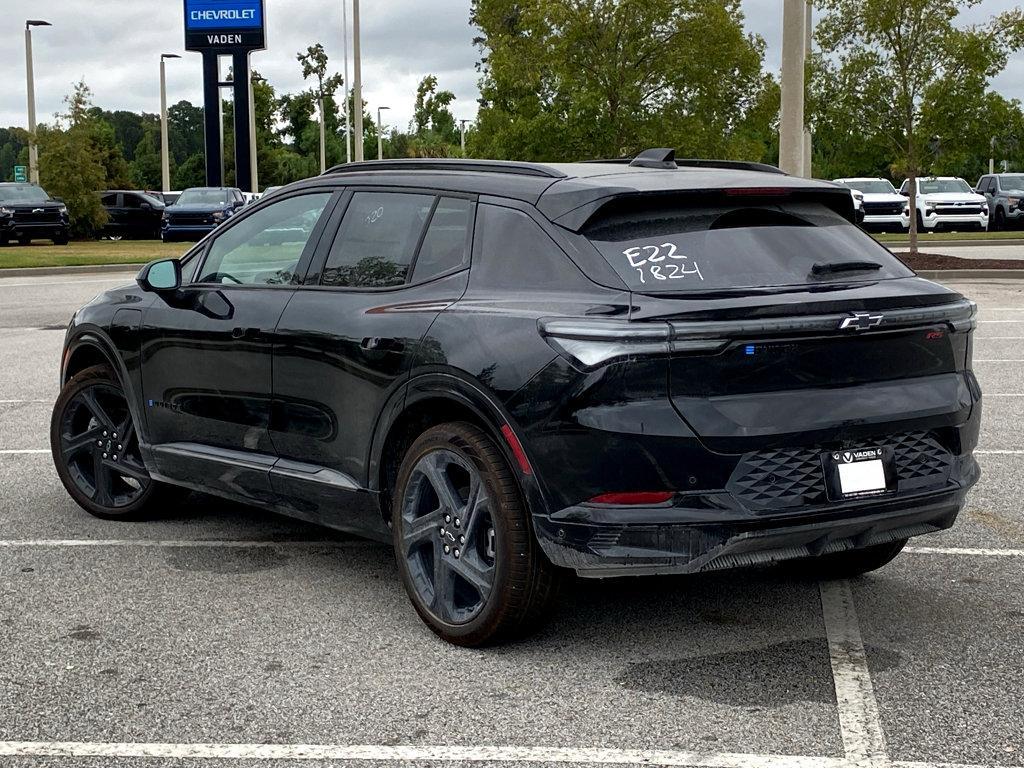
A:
<box><xmin>471</xmin><ymin>0</ymin><xmax>771</xmax><ymax>160</ymax></box>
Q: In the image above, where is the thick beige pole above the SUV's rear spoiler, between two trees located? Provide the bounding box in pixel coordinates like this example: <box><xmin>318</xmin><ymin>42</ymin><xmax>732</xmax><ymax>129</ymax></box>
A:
<box><xmin>778</xmin><ymin>0</ymin><xmax>807</xmax><ymax>176</ymax></box>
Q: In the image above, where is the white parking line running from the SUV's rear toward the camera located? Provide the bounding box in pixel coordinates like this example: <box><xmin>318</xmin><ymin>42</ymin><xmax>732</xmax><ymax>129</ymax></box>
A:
<box><xmin>818</xmin><ymin>580</ymin><xmax>889</xmax><ymax>766</ymax></box>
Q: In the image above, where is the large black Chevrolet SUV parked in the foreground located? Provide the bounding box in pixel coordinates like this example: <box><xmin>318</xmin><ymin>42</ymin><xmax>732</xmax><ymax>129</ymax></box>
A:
<box><xmin>51</xmin><ymin>152</ymin><xmax>981</xmax><ymax>645</ymax></box>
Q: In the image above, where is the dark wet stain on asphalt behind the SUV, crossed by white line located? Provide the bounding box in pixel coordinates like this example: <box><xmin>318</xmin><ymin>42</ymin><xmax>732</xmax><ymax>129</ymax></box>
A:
<box><xmin>614</xmin><ymin>638</ymin><xmax>899</xmax><ymax>709</ymax></box>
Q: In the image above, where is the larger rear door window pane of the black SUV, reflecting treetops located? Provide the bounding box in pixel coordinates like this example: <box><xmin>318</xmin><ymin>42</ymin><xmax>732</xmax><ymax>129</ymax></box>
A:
<box><xmin>322</xmin><ymin>193</ymin><xmax>434</xmax><ymax>289</ymax></box>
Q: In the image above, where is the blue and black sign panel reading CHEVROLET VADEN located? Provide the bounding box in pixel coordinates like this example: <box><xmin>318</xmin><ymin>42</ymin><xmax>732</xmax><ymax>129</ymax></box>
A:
<box><xmin>184</xmin><ymin>0</ymin><xmax>266</xmax><ymax>51</ymax></box>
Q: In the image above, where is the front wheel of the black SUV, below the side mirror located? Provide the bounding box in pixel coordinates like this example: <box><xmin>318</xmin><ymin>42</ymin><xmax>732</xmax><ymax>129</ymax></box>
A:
<box><xmin>50</xmin><ymin>367</ymin><xmax>159</xmax><ymax>518</ymax></box>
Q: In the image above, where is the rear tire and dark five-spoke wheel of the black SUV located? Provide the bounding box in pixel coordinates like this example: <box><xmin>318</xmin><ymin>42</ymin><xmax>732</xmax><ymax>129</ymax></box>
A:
<box><xmin>392</xmin><ymin>423</ymin><xmax>557</xmax><ymax>646</ymax></box>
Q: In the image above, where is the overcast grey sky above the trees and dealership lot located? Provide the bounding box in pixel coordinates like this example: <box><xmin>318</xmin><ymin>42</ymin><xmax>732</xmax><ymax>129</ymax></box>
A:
<box><xmin>0</xmin><ymin>0</ymin><xmax>1024</xmax><ymax>134</ymax></box>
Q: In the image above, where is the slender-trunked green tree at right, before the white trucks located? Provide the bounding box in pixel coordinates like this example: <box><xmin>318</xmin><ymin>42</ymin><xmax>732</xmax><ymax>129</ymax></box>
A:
<box><xmin>817</xmin><ymin>0</ymin><xmax>1024</xmax><ymax>253</ymax></box>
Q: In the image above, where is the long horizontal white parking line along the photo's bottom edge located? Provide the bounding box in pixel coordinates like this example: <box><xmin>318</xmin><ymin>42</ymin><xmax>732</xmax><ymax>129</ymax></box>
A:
<box><xmin>0</xmin><ymin>742</ymin><xmax>872</xmax><ymax>769</ymax></box>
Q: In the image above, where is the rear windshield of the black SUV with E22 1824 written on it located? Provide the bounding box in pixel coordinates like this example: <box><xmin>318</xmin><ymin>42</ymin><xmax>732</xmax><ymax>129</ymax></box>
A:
<box><xmin>585</xmin><ymin>201</ymin><xmax>913</xmax><ymax>293</ymax></box>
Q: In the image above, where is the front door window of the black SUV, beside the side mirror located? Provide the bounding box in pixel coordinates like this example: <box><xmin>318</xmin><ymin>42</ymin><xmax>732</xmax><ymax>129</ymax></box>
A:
<box><xmin>199</xmin><ymin>193</ymin><xmax>331</xmax><ymax>286</ymax></box>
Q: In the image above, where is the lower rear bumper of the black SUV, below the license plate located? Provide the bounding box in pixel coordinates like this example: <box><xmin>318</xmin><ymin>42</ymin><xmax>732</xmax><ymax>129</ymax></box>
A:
<box><xmin>535</xmin><ymin>456</ymin><xmax>980</xmax><ymax>578</ymax></box>
